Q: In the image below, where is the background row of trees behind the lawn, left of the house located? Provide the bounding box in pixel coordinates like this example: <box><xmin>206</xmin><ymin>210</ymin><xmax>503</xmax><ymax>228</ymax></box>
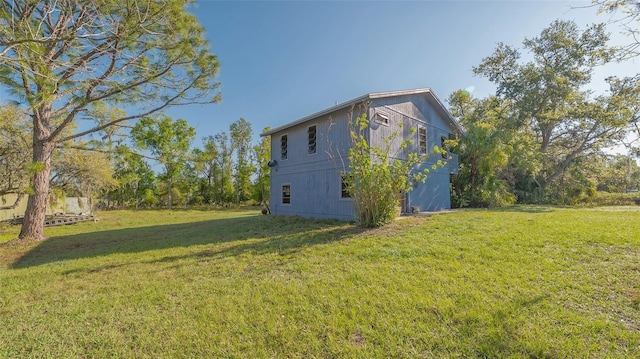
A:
<box><xmin>0</xmin><ymin>108</ymin><xmax>270</xmax><ymax>209</ymax></box>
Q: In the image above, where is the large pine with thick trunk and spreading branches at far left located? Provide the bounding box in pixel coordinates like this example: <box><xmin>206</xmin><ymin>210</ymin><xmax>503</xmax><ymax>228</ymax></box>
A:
<box><xmin>0</xmin><ymin>0</ymin><xmax>219</xmax><ymax>240</ymax></box>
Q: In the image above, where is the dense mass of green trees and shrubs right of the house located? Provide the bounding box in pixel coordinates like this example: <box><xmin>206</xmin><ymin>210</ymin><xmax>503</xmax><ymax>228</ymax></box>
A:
<box><xmin>452</xmin><ymin>21</ymin><xmax>640</xmax><ymax>206</ymax></box>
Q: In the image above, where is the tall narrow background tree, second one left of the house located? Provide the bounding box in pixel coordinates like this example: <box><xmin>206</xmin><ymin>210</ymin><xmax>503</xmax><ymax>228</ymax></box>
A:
<box><xmin>229</xmin><ymin>118</ymin><xmax>254</xmax><ymax>205</ymax></box>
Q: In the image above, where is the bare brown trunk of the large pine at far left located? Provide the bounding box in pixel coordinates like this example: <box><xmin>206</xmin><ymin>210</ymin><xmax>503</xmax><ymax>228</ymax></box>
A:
<box><xmin>18</xmin><ymin>141</ymin><xmax>55</xmax><ymax>241</ymax></box>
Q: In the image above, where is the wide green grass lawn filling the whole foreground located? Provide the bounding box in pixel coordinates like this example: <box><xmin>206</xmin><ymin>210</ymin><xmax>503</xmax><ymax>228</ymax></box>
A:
<box><xmin>0</xmin><ymin>207</ymin><xmax>640</xmax><ymax>358</ymax></box>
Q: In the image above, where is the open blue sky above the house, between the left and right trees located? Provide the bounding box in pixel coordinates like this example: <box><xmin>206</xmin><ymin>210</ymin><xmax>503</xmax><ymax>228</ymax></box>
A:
<box><xmin>168</xmin><ymin>0</ymin><xmax>640</xmax><ymax>147</ymax></box>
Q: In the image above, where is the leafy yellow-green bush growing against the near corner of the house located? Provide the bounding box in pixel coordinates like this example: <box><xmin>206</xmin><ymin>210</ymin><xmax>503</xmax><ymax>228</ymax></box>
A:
<box><xmin>344</xmin><ymin>113</ymin><xmax>429</xmax><ymax>227</ymax></box>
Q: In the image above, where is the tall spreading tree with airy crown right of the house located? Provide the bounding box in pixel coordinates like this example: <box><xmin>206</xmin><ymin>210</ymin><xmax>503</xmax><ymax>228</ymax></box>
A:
<box><xmin>474</xmin><ymin>21</ymin><xmax>630</xmax><ymax>200</ymax></box>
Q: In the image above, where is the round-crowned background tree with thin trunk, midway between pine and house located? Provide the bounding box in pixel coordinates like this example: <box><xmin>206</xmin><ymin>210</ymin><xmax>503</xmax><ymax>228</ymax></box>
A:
<box><xmin>131</xmin><ymin>115</ymin><xmax>196</xmax><ymax>209</ymax></box>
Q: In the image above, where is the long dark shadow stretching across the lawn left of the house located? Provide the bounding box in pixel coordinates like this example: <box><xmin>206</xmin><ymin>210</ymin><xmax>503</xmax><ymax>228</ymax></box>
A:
<box><xmin>11</xmin><ymin>216</ymin><xmax>364</xmax><ymax>269</ymax></box>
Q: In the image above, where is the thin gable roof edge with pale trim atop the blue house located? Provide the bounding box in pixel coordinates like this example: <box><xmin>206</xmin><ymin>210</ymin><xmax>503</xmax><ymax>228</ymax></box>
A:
<box><xmin>260</xmin><ymin>87</ymin><xmax>464</xmax><ymax>137</ymax></box>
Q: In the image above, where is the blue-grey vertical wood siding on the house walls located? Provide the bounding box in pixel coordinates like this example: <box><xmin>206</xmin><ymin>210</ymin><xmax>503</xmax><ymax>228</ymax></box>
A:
<box><xmin>271</xmin><ymin>94</ymin><xmax>458</xmax><ymax>220</ymax></box>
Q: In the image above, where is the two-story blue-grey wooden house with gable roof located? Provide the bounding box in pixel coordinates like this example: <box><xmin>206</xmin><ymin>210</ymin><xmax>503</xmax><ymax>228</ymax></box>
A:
<box><xmin>262</xmin><ymin>88</ymin><xmax>462</xmax><ymax>220</ymax></box>
